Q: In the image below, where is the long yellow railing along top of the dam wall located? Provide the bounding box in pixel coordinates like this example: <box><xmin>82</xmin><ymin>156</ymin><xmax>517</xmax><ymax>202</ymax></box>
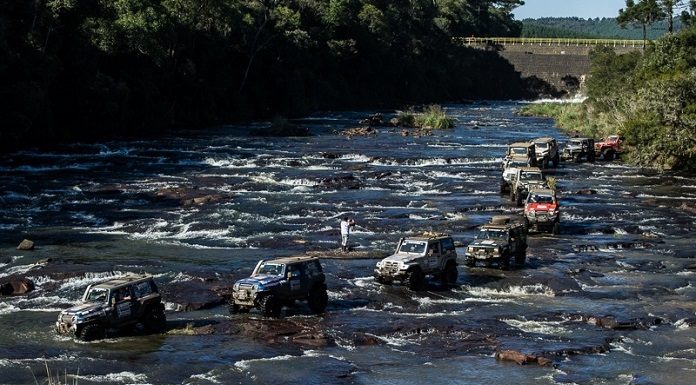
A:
<box><xmin>454</xmin><ymin>37</ymin><xmax>643</xmax><ymax>48</ymax></box>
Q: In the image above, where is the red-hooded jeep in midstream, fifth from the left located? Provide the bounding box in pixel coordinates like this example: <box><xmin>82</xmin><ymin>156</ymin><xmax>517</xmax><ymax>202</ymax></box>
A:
<box><xmin>524</xmin><ymin>189</ymin><xmax>561</xmax><ymax>235</ymax></box>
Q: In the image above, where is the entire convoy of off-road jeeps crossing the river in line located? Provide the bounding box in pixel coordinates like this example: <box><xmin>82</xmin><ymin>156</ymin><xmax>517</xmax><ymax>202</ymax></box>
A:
<box><xmin>55</xmin><ymin>131</ymin><xmax>622</xmax><ymax>341</ymax></box>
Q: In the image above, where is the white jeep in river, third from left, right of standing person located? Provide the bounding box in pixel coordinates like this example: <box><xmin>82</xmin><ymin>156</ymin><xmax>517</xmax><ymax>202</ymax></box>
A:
<box><xmin>374</xmin><ymin>235</ymin><xmax>458</xmax><ymax>290</ymax></box>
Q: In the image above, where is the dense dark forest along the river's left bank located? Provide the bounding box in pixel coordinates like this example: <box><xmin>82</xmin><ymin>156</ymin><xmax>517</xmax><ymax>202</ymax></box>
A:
<box><xmin>0</xmin><ymin>0</ymin><xmax>526</xmax><ymax>149</ymax></box>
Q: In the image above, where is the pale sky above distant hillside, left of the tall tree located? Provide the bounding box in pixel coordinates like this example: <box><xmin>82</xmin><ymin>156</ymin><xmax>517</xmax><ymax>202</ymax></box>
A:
<box><xmin>513</xmin><ymin>0</ymin><xmax>626</xmax><ymax>20</ymax></box>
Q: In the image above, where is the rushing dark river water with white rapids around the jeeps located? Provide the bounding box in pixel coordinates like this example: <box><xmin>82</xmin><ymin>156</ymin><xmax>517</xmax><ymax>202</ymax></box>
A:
<box><xmin>0</xmin><ymin>102</ymin><xmax>696</xmax><ymax>385</ymax></box>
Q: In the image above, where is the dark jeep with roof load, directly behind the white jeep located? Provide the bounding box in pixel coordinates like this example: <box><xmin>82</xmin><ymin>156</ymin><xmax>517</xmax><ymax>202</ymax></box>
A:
<box><xmin>465</xmin><ymin>216</ymin><xmax>527</xmax><ymax>270</ymax></box>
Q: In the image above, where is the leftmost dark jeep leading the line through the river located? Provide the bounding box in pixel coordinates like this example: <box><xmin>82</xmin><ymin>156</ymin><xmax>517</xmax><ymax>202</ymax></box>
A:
<box><xmin>56</xmin><ymin>275</ymin><xmax>167</xmax><ymax>341</ymax></box>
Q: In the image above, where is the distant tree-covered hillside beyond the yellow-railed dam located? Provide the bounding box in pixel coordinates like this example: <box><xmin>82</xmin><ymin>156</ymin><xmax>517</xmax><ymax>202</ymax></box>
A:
<box><xmin>522</xmin><ymin>17</ymin><xmax>681</xmax><ymax>40</ymax></box>
